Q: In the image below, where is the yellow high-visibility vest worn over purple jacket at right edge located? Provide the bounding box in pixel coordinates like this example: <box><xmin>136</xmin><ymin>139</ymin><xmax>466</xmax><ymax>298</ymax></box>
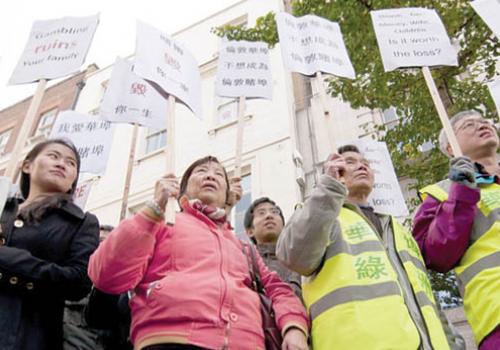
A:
<box><xmin>420</xmin><ymin>180</ymin><xmax>500</xmax><ymax>344</ymax></box>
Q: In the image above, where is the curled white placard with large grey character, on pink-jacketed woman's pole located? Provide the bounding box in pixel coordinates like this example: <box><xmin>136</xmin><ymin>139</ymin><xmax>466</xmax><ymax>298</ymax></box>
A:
<box><xmin>134</xmin><ymin>21</ymin><xmax>202</xmax><ymax>118</ymax></box>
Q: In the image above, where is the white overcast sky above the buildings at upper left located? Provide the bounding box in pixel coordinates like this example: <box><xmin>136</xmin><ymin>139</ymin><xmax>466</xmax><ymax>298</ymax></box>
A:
<box><xmin>0</xmin><ymin>0</ymin><xmax>238</xmax><ymax>109</ymax></box>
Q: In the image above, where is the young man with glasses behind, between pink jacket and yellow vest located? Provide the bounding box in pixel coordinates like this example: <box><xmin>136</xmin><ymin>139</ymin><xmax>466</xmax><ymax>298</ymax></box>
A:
<box><xmin>243</xmin><ymin>197</ymin><xmax>301</xmax><ymax>298</ymax></box>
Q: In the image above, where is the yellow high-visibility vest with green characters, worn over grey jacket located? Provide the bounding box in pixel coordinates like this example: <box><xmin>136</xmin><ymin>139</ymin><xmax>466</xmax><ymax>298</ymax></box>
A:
<box><xmin>302</xmin><ymin>208</ymin><xmax>449</xmax><ymax>350</ymax></box>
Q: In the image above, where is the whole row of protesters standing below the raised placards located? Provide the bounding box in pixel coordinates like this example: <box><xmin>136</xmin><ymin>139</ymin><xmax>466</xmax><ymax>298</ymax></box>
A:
<box><xmin>0</xmin><ymin>111</ymin><xmax>500</xmax><ymax>350</ymax></box>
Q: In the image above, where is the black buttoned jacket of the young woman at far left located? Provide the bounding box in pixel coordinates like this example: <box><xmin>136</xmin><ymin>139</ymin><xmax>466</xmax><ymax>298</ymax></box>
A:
<box><xmin>0</xmin><ymin>199</ymin><xmax>99</xmax><ymax>350</ymax></box>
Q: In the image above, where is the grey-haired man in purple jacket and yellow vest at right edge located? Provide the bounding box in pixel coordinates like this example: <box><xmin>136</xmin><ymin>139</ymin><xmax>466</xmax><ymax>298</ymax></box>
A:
<box><xmin>413</xmin><ymin>111</ymin><xmax>500</xmax><ymax>350</ymax></box>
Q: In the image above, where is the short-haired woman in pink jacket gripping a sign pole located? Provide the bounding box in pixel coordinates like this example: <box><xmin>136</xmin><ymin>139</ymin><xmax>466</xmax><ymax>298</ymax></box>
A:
<box><xmin>89</xmin><ymin>156</ymin><xmax>308</xmax><ymax>350</ymax></box>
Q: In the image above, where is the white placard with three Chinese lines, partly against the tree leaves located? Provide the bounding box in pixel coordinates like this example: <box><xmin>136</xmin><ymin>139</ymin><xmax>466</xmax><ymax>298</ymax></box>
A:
<box><xmin>276</xmin><ymin>12</ymin><xmax>355</xmax><ymax>79</ymax></box>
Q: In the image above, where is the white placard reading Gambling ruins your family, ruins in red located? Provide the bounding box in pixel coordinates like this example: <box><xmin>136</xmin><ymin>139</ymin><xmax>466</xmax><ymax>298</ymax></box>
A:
<box><xmin>9</xmin><ymin>15</ymin><xmax>99</xmax><ymax>85</ymax></box>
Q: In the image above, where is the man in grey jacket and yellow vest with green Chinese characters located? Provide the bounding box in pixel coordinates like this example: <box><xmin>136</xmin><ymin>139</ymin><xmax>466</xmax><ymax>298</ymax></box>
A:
<box><xmin>277</xmin><ymin>145</ymin><xmax>458</xmax><ymax>350</ymax></box>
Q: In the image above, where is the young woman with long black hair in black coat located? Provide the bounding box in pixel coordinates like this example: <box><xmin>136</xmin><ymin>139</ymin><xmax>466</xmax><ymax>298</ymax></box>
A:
<box><xmin>0</xmin><ymin>139</ymin><xmax>99</xmax><ymax>350</ymax></box>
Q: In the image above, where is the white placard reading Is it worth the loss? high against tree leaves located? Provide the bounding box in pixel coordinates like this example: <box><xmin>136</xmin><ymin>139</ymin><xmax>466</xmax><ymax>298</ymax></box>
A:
<box><xmin>370</xmin><ymin>7</ymin><xmax>458</xmax><ymax>72</ymax></box>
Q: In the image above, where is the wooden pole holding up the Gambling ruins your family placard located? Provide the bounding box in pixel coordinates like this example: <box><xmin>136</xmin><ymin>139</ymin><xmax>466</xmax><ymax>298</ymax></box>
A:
<box><xmin>5</xmin><ymin>79</ymin><xmax>47</xmax><ymax>182</ymax></box>
